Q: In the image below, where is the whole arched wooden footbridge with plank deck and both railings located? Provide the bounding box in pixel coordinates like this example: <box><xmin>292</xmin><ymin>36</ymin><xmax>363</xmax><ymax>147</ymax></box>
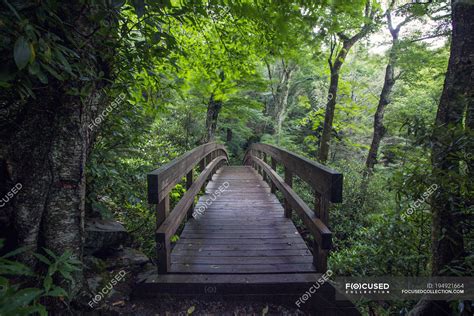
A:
<box><xmin>136</xmin><ymin>143</ymin><xmax>357</xmax><ymax>315</ymax></box>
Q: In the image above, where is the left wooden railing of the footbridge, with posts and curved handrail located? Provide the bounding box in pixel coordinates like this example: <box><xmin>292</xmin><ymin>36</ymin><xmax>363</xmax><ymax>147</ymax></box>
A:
<box><xmin>147</xmin><ymin>143</ymin><xmax>228</xmax><ymax>273</ymax></box>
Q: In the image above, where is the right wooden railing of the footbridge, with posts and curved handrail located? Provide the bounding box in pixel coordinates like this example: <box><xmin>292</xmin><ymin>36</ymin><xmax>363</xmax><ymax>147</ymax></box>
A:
<box><xmin>244</xmin><ymin>143</ymin><xmax>343</xmax><ymax>272</ymax></box>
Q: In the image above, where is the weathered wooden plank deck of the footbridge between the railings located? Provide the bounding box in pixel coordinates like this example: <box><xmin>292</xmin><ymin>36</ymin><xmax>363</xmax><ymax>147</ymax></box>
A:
<box><xmin>169</xmin><ymin>166</ymin><xmax>316</xmax><ymax>274</ymax></box>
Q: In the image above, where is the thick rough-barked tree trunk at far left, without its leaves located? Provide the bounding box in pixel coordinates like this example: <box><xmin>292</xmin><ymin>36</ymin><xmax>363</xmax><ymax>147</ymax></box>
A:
<box><xmin>0</xmin><ymin>2</ymin><xmax>113</xmax><ymax>295</ymax></box>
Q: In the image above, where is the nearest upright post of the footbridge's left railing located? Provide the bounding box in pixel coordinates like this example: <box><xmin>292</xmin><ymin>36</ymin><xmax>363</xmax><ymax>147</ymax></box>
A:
<box><xmin>156</xmin><ymin>194</ymin><xmax>171</xmax><ymax>273</ymax></box>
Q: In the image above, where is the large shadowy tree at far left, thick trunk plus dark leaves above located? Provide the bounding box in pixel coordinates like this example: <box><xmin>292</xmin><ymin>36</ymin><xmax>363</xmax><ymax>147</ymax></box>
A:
<box><xmin>0</xmin><ymin>2</ymin><xmax>115</xmax><ymax>296</ymax></box>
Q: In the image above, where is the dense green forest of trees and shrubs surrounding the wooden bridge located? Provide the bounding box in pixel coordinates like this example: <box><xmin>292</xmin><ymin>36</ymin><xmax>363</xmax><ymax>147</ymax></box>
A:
<box><xmin>0</xmin><ymin>0</ymin><xmax>474</xmax><ymax>315</ymax></box>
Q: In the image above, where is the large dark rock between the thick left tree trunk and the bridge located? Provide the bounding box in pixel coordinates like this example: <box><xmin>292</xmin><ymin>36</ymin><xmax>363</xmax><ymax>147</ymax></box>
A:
<box><xmin>84</xmin><ymin>219</ymin><xmax>130</xmax><ymax>255</ymax></box>
